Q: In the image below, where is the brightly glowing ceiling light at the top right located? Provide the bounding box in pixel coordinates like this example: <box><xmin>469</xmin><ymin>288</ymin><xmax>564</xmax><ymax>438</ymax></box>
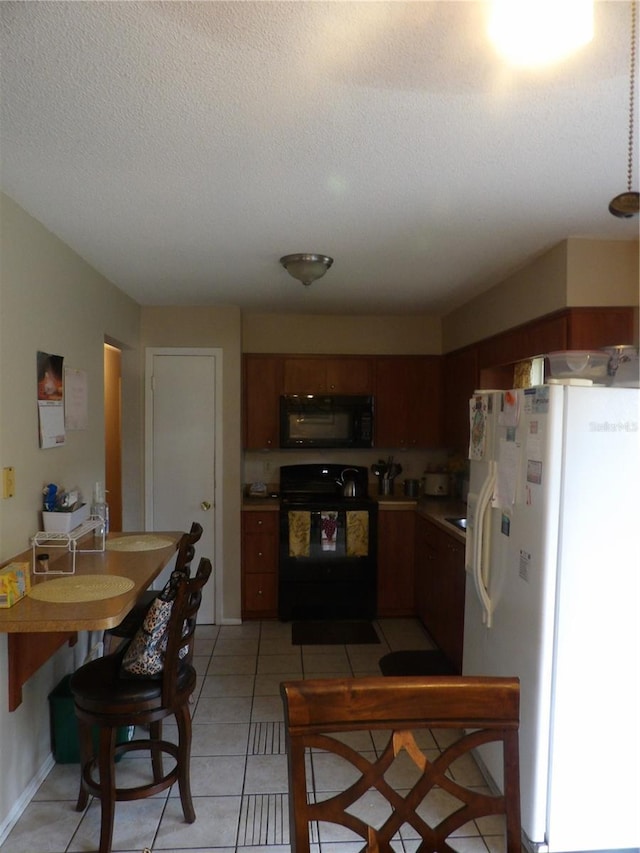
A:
<box><xmin>487</xmin><ymin>0</ymin><xmax>593</xmax><ymax>68</ymax></box>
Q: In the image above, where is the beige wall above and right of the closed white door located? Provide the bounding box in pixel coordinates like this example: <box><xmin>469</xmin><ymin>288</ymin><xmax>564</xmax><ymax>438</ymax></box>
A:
<box><xmin>141</xmin><ymin>306</ymin><xmax>242</xmax><ymax>621</ymax></box>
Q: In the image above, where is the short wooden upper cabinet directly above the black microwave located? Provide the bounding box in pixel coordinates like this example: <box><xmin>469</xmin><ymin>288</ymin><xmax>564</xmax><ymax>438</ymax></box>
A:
<box><xmin>283</xmin><ymin>355</ymin><xmax>373</xmax><ymax>394</ymax></box>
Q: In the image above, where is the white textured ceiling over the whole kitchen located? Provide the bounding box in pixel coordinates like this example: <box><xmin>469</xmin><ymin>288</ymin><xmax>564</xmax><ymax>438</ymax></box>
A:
<box><xmin>0</xmin><ymin>0</ymin><xmax>638</xmax><ymax>314</ymax></box>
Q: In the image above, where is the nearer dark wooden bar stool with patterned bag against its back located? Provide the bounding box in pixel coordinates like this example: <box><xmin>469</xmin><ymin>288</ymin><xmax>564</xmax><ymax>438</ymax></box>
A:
<box><xmin>70</xmin><ymin>557</ymin><xmax>211</xmax><ymax>853</ymax></box>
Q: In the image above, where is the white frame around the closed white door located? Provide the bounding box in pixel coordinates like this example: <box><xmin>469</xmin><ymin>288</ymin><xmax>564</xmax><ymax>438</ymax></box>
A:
<box><xmin>144</xmin><ymin>347</ymin><xmax>224</xmax><ymax>625</ymax></box>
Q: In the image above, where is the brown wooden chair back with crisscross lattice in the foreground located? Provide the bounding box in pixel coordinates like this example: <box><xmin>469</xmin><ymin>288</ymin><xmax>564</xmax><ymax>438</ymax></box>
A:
<box><xmin>281</xmin><ymin>676</ymin><xmax>521</xmax><ymax>853</ymax></box>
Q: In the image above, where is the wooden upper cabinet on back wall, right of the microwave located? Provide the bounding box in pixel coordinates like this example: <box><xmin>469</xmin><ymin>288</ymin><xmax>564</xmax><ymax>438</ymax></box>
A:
<box><xmin>375</xmin><ymin>356</ymin><xmax>442</xmax><ymax>449</ymax></box>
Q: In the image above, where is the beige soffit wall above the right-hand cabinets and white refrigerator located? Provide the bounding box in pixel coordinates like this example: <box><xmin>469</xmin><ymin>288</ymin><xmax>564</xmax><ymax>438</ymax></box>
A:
<box><xmin>442</xmin><ymin>237</ymin><xmax>638</xmax><ymax>352</ymax></box>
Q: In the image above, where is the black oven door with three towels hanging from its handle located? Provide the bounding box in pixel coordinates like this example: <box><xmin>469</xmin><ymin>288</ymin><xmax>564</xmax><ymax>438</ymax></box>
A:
<box><xmin>278</xmin><ymin>501</ymin><xmax>377</xmax><ymax>620</ymax></box>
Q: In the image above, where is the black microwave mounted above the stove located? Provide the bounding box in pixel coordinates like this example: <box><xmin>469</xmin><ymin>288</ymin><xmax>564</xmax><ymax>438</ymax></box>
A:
<box><xmin>280</xmin><ymin>394</ymin><xmax>373</xmax><ymax>448</ymax></box>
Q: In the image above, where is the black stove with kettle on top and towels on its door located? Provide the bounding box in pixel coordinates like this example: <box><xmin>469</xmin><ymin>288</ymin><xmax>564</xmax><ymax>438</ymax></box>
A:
<box><xmin>278</xmin><ymin>463</ymin><xmax>378</xmax><ymax>620</ymax></box>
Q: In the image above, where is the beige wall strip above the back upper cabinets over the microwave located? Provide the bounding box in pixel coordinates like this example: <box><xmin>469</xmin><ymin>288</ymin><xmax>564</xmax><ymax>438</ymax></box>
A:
<box><xmin>242</xmin><ymin>314</ymin><xmax>442</xmax><ymax>355</ymax></box>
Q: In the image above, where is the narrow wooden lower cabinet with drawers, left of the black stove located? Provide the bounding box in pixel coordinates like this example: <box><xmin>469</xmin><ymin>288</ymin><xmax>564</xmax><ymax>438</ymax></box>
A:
<box><xmin>242</xmin><ymin>510</ymin><xmax>278</xmax><ymax>619</ymax></box>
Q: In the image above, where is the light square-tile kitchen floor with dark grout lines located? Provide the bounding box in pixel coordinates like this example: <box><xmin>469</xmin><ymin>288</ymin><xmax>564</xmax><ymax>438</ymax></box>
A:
<box><xmin>0</xmin><ymin>619</ymin><xmax>504</xmax><ymax>853</ymax></box>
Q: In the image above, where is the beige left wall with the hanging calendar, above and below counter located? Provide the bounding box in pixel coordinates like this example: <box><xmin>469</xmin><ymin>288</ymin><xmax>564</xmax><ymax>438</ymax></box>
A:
<box><xmin>0</xmin><ymin>194</ymin><xmax>142</xmax><ymax>834</ymax></box>
